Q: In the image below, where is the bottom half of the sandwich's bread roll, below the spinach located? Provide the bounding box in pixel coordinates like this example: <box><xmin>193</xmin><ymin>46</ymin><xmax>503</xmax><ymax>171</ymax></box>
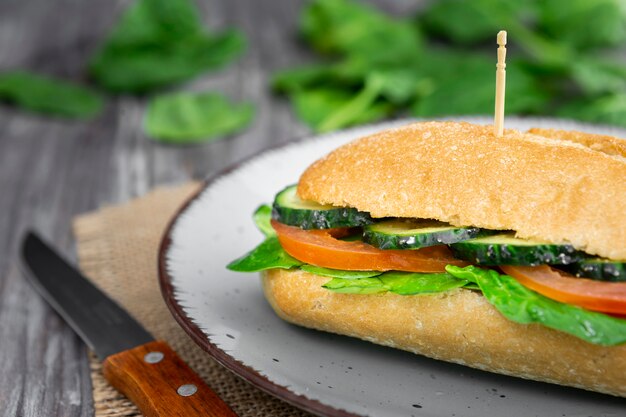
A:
<box><xmin>262</xmin><ymin>269</ymin><xmax>626</xmax><ymax>397</ymax></box>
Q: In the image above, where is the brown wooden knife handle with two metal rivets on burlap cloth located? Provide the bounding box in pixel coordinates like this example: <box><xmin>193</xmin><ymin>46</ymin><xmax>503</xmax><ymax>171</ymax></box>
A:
<box><xmin>102</xmin><ymin>341</ymin><xmax>237</xmax><ymax>417</ymax></box>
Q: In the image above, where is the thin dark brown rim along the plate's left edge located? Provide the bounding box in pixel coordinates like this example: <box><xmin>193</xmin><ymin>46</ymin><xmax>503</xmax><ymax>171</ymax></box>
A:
<box><xmin>157</xmin><ymin>134</ymin><xmax>358</xmax><ymax>417</ymax></box>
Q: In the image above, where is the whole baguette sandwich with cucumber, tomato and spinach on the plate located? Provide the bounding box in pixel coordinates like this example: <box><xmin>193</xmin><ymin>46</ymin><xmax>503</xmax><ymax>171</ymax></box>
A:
<box><xmin>228</xmin><ymin>122</ymin><xmax>626</xmax><ymax>397</ymax></box>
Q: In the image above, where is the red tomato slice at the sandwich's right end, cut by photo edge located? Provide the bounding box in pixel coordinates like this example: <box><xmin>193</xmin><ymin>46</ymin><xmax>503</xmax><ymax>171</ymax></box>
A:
<box><xmin>500</xmin><ymin>265</ymin><xmax>626</xmax><ymax>316</ymax></box>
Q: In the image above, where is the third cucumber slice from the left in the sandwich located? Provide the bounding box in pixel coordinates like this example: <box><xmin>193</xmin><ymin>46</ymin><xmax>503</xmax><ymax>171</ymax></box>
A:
<box><xmin>450</xmin><ymin>233</ymin><xmax>584</xmax><ymax>266</ymax></box>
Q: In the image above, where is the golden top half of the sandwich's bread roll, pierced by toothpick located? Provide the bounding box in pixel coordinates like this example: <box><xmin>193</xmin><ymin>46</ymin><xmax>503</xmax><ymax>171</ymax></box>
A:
<box><xmin>298</xmin><ymin>118</ymin><xmax>626</xmax><ymax>259</ymax></box>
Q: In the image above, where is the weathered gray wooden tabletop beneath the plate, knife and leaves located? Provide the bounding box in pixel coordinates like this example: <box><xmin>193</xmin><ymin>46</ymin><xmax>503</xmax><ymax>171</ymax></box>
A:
<box><xmin>0</xmin><ymin>0</ymin><xmax>415</xmax><ymax>417</ymax></box>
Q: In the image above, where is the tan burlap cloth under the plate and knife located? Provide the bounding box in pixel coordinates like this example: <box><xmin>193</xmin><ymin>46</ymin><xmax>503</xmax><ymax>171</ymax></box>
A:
<box><xmin>74</xmin><ymin>183</ymin><xmax>308</xmax><ymax>417</ymax></box>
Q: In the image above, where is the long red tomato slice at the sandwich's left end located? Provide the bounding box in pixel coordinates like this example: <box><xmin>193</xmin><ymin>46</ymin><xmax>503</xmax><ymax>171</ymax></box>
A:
<box><xmin>272</xmin><ymin>220</ymin><xmax>468</xmax><ymax>272</ymax></box>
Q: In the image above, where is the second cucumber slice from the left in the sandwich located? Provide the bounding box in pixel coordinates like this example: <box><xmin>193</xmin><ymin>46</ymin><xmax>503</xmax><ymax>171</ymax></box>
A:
<box><xmin>363</xmin><ymin>219</ymin><xmax>497</xmax><ymax>249</ymax></box>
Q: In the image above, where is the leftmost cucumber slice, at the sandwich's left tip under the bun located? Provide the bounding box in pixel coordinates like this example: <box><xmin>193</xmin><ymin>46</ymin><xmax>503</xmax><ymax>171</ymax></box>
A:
<box><xmin>272</xmin><ymin>185</ymin><xmax>373</xmax><ymax>229</ymax></box>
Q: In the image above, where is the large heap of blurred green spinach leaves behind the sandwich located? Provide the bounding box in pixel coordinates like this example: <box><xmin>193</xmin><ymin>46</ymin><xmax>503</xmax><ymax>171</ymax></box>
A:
<box><xmin>272</xmin><ymin>0</ymin><xmax>626</xmax><ymax>131</ymax></box>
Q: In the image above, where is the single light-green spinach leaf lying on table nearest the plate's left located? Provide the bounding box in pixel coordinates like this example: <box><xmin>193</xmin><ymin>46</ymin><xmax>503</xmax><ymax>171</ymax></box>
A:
<box><xmin>145</xmin><ymin>93</ymin><xmax>254</xmax><ymax>144</ymax></box>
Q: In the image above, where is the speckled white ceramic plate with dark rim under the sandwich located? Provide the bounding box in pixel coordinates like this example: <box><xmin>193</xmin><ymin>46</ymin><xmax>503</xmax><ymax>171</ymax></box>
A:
<box><xmin>160</xmin><ymin>118</ymin><xmax>626</xmax><ymax>417</ymax></box>
